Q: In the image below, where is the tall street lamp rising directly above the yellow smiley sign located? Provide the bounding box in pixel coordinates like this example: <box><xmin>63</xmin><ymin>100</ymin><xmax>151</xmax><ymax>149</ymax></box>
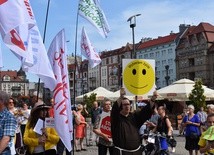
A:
<box><xmin>127</xmin><ymin>14</ymin><xmax>141</xmax><ymax>59</ymax></box>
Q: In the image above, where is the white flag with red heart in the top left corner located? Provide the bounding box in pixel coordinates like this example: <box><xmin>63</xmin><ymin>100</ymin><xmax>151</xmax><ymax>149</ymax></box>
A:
<box><xmin>0</xmin><ymin>0</ymin><xmax>36</xmax><ymax>58</ymax></box>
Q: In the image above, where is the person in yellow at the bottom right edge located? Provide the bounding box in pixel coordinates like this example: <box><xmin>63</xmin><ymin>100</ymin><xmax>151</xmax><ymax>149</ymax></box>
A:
<box><xmin>198</xmin><ymin>113</ymin><xmax>214</xmax><ymax>154</ymax></box>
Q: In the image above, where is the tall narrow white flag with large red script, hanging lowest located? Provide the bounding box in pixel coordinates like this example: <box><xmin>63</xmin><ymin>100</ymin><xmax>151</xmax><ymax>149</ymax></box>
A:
<box><xmin>48</xmin><ymin>29</ymin><xmax>73</xmax><ymax>151</ymax></box>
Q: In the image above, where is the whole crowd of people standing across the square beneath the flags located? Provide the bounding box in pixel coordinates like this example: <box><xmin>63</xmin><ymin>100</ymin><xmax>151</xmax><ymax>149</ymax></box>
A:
<box><xmin>0</xmin><ymin>89</ymin><xmax>214</xmax><ymax>155</ymax></box>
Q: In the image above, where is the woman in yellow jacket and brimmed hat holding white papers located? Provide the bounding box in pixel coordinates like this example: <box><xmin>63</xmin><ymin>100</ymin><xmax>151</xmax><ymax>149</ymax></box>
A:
<box><xmin>24</xmin><ymin>101</ymin><xmax>59</xmax><ymax>155</ymax></box>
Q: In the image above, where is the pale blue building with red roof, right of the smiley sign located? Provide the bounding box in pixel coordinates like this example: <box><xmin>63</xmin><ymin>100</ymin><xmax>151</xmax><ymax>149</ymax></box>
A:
<box><xmin>136</xmin><ymin>33</ymin><xmax>178</xmax><ymax>89</ymax></box>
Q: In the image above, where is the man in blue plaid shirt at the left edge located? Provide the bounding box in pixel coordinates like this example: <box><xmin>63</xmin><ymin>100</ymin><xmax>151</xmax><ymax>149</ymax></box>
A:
<box><xmin>0</xmin><ymin>91</ymin><xmax>17</xmax><ymax>155</ymax></box>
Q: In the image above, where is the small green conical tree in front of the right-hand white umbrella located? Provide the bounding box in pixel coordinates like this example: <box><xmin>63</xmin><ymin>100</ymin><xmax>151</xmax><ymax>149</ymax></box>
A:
<box><xmin>189</xmin><ymin>80</ymin><xmax>206</xmax><ymax>111</ymax></box>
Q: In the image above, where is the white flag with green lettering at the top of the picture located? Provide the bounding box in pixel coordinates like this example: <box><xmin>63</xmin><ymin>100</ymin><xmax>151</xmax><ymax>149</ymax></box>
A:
<box><xmin>78</xmin><ymin>0</ymin><xmax>110</xmax><ymax>37</ymax></box>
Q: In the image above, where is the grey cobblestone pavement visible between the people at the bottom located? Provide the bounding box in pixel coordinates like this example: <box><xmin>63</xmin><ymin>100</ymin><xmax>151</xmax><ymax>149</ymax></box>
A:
<box><xmin>64</xmin><ymin>130</ymin><xmax>188</xmax><ymax>155</ymax></box>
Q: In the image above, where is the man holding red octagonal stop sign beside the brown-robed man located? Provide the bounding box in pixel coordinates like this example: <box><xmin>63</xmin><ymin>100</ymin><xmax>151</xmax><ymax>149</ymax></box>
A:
<box><xmin>93</xmin><ymin>99</ymin><xmax>113</xmax><ymax>155</ymax></box>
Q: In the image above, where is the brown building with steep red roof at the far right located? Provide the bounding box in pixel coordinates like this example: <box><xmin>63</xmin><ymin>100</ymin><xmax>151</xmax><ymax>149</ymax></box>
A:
<box><xmin>176</xmin><ymin>23</ymin><xmax>214</xmax><ymax>88</ymax></box>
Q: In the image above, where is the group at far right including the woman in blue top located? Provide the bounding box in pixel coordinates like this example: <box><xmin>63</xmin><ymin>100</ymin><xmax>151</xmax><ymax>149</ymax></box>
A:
<box><xmin>180</xmin><ymin>104</ymin><xmax>214</xmax><ymax>155</ymax></box>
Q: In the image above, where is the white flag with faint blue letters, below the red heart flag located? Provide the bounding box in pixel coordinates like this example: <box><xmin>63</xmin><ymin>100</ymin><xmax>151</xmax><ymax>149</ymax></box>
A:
<box><xmin>22</xmin><ymin>26</ymin><xmax>56</xmax><ymax>91</ymax></box>
